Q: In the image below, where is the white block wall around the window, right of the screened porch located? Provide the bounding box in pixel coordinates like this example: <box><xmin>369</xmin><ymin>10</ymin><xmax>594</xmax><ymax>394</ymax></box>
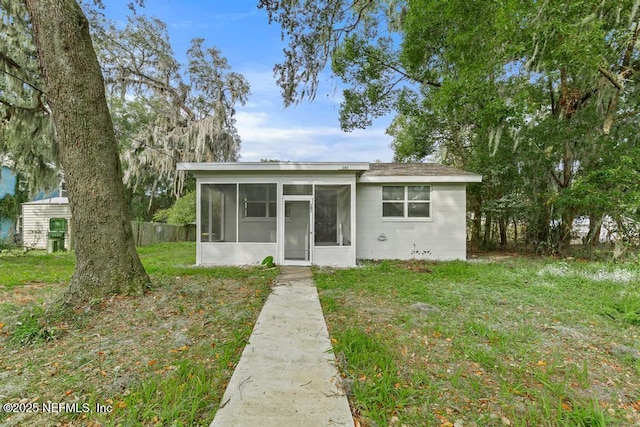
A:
<box><xmin>356</xmin><ymin>183</ymin><xmax>467</xmax><ymax>260</ymax></box>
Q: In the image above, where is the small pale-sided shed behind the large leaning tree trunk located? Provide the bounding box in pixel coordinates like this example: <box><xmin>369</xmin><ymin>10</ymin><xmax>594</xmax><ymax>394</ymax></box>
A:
<box><xmin>22</xmin><ymin>197</ymin><xmax>71</xmax><ymax>250</ymax></box>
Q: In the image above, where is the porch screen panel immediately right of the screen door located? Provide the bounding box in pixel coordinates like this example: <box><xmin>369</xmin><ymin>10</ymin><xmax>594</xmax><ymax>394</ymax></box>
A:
<box><xmin>314</xmin><ymin>185</ymin><xmax>351</xmax><ymax>246</ymax></box>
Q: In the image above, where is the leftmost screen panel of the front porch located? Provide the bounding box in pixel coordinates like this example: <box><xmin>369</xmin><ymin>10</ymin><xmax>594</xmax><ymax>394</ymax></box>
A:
<box><xmin>200</xmin><ymin>184</ymin><xmax>237</xmax><ymax>242</ymax></box>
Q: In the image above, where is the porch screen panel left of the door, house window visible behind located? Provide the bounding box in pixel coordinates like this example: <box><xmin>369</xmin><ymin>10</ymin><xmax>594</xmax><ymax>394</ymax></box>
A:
<box><xmin>238</xmin><ymin>184</ymin><xmax>278</xmax><ymax>243</ymax></box>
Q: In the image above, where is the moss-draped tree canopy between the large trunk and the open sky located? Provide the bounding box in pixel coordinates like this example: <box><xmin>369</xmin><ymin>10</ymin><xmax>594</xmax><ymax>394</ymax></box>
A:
<box><xmin>94</xmin><ymin>15</ymin><xmax>249</xmax><ymax>194</ymax></box>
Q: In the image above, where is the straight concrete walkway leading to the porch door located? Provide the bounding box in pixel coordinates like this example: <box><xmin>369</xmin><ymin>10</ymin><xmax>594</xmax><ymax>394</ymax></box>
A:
<box><xmin>211</xmin><ymin>267</ymin><xmax>354</xmax><ymax>427</ymax></box>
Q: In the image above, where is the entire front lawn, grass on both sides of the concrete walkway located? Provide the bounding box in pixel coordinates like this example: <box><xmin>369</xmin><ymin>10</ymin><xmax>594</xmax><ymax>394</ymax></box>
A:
<box><xmin>0</xmin><ymin>249</ymin><xmax>640</xmax><ymax>427</ymax></box>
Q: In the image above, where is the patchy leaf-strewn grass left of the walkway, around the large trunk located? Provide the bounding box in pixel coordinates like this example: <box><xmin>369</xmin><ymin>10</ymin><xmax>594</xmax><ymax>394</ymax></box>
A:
<box><xmin>0</xmin><ymin>243</ymin><xmax>277</xmax><ymax>426</ymax></box>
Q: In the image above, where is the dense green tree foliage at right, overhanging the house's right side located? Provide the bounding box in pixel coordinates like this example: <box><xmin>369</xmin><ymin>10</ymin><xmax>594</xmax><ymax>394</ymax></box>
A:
<box><xmin>260</xmin><ymin>0</ymin><xmax>640</xmax><ymax>252</ymax></box>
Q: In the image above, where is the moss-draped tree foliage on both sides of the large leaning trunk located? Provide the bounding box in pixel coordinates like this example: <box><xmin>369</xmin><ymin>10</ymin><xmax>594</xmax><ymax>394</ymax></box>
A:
<box><xmin>0</xmin><ymin>0</ymin><xmax>249</xmax><ymax>205</ymax></box>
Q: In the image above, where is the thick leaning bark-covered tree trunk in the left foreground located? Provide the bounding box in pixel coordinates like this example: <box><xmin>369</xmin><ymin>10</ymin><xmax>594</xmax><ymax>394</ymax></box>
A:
<box><xmin>25</xmin><ymin>0</ymin><xmax>149</xmax><ymax>305</ymax></box>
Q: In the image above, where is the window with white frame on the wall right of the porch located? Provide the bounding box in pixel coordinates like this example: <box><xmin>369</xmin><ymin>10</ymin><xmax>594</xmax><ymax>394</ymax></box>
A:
<box><xmin>382</xmin><ymin>185</ymin><xmax>431</xmax><ymax>219</ymax></box>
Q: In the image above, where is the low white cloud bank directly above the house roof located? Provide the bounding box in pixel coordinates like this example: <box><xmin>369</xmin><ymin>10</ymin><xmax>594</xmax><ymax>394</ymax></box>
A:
<box><xmin>236</xmin><ymin>67</ymin><xmax>393</xmax><ymax>162</ymax></box>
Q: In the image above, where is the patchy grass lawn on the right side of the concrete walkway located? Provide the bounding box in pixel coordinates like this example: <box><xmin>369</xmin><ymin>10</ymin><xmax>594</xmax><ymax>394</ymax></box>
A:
<box><xmin>315</xmin><ymin>257</ymin><xmax>640</xmax><ymax>427</ymax></box>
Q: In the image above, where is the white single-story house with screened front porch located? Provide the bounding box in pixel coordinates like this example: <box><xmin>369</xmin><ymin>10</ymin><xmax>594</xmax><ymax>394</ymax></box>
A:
<box><xmin>178</xmin><ymin>162</ymin><xmax>482</xmax><ymax>267</ymax></box>
